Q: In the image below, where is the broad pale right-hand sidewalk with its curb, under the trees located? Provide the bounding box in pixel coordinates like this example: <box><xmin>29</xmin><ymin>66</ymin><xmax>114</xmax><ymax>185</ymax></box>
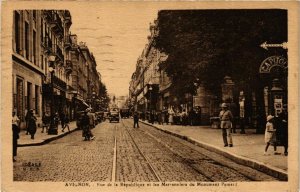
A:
<box><xmin>141</xmin><ymin>121</ymin><xmax>288</xmax><ymax>180</ymax></box>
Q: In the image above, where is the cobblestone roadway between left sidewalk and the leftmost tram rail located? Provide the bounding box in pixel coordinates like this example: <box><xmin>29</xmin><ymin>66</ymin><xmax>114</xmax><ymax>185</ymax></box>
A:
<box><xmin>13</xmin><ymin>124</ymin><xmax>114</xmax><ymax>181</ymax></box>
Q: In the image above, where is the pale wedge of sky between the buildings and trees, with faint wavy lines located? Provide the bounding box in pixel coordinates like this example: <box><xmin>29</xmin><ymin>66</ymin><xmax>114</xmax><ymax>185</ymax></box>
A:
<box><xmin>69</xmin><ymin>4</ymin><xmax>158</xmax><ymax>96</ymax></box>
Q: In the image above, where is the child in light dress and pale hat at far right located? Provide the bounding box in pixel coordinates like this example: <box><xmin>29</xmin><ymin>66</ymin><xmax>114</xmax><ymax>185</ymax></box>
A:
<box><xmin>264</xmin><ymin>115</ymin><xmax>277</xmax><ymax>155</ymax></box>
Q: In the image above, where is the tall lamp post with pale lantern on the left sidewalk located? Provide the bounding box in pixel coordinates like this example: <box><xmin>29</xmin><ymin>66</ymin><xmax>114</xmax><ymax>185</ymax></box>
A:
<box><xmin>48</xmin><ymin>55</ymin><xmax>57</xmax><ymax>135</ymax></box>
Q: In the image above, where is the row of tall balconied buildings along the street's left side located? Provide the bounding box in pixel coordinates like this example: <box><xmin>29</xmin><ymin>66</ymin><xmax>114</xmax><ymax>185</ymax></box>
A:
<box><xmin>12</xmin><ymin>10</ymin><xmax>102</xmax><ymax>125</ymax></box>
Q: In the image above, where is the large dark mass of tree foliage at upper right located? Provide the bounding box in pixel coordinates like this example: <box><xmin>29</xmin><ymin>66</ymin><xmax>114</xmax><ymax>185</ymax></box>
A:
<box><xmin>155</xmin><ymin>9</ymin><xmax>287</xmax><ymax>97</ymax></box>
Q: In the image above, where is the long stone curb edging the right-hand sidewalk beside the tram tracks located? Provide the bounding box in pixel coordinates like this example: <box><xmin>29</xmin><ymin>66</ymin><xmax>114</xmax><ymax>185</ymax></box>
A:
<box><xmin>140</xmin><ymin>121</ymin><xmax>288</xmax><ymax>181</ymax></box>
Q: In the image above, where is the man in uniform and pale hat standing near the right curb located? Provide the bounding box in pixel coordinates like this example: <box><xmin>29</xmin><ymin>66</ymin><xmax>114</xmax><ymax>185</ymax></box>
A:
<box><xmin>219</xmin><ymin>103</ymin><xmax>233</xmax><ymax>147</ymax></box>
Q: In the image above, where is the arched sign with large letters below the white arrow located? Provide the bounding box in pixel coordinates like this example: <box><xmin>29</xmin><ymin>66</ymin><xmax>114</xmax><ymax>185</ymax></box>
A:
<box><xmin>259</xmin><ymin>56</ymin><xmax>288</xmax><ymax>73</ymax></box>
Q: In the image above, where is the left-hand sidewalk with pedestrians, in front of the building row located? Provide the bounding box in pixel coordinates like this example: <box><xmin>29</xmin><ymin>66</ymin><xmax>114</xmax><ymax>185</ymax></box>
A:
<box><xmin>18</xmin><ymin>121</ymin><xmax>77</xmax><ymax>147</ymax></box>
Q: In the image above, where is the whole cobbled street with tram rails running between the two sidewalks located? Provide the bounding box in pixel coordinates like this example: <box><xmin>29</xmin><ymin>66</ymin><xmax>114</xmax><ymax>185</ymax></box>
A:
<box><xmin>13</xmin><ymin>119</ymin><xmax>276</xmax><ymax>182</ymax></box>
